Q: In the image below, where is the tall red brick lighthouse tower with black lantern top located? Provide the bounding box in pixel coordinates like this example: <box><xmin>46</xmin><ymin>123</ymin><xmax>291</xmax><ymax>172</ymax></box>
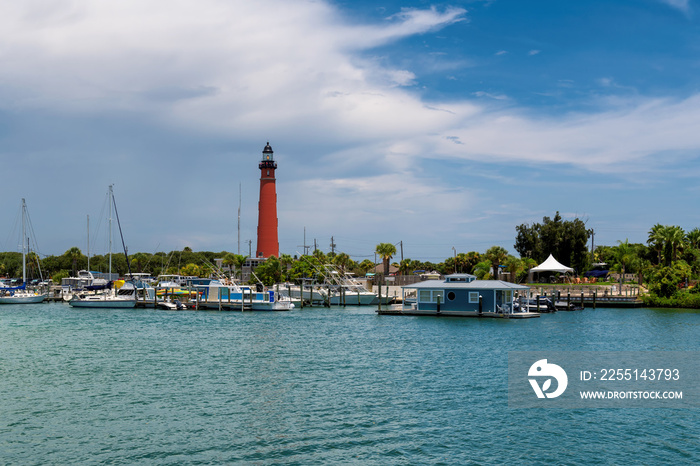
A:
<box><xmin>255</xmin><ymin>142</ymin><xmax>280</xmax><ymax>257</ymax></box>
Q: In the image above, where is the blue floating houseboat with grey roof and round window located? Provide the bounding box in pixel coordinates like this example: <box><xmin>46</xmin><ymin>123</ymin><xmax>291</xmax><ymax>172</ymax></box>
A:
<box><xmin>388</xmin><ymin>274</ymin><xmax>540</xmax><ymax>319</ymax></box>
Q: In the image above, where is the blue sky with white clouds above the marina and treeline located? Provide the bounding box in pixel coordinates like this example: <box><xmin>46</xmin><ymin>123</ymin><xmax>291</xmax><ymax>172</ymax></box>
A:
<box><xmin>0</xmin><ymin>0</ymin><xmax>700</xmax><ymax>262</ymax></box>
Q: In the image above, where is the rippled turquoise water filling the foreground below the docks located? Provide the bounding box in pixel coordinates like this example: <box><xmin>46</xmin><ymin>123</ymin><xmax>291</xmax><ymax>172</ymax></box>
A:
<box><xmin>0</xmin><ymin>304</ymin><xmax>700</xmax><ymax>465</ymax></box>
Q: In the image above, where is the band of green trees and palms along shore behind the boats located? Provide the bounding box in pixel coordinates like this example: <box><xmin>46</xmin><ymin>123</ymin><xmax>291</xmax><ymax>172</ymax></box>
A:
<box><xmin>0</xmin><ymin>212</ymin><xmax>700</xmax><ymax>309</ymax></box>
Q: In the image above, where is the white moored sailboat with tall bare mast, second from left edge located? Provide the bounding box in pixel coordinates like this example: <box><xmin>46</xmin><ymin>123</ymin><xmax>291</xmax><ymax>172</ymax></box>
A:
<box><xmin>68</xmin><ymin>185</ymin><xmax>136</xmax><ymax>309</ymax></box>
